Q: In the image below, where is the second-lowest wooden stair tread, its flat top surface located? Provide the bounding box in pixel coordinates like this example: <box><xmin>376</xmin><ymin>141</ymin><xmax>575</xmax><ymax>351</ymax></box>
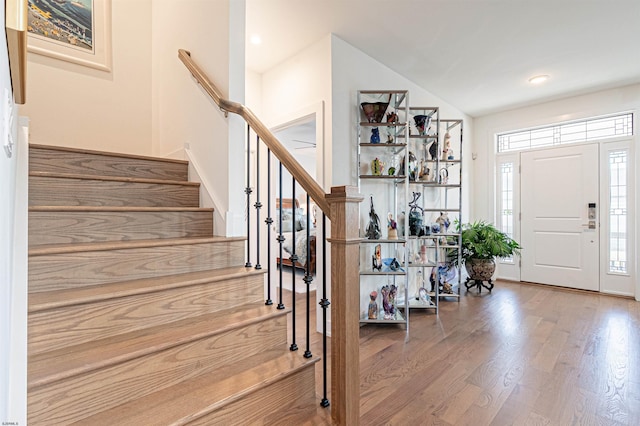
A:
<box><xmin>28</xmin><ymin>303</ymin><xmax>290</xmax><ymax>389</ymax></box>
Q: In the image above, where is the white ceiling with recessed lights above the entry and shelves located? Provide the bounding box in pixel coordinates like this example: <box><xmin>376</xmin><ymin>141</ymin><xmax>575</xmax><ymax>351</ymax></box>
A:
<box><xmin>246</xmin><ymin>0</ymin><xmax>640</xmax><ymax>117</ymax></box>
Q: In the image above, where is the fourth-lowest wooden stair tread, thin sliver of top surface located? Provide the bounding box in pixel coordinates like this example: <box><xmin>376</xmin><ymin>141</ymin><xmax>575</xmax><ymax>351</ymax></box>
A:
<box><xmin>29</xmin><ymin>237</ymin><xmax>245</xmax><ymax>256</ymax></box>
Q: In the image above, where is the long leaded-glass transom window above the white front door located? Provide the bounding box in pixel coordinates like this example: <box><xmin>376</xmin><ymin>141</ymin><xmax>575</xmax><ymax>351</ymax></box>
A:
<box><xmin>498</xmin><ymin>112</ymin><xmax>633</xmax><ymax>152</ymax></box>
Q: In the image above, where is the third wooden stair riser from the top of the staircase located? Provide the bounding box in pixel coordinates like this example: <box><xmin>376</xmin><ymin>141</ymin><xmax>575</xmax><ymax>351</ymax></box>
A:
<box><xmin>29</xmin><ymin>211</ymin><xmax>213</xmax><ymax>247</ymax></box>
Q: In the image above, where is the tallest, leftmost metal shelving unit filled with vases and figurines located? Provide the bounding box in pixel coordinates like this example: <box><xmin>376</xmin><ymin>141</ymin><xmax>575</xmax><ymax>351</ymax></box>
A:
<box><xmin>356</xmin><ymin>90</ymin><xmax>409</xmax><ymax>330</ymax></box>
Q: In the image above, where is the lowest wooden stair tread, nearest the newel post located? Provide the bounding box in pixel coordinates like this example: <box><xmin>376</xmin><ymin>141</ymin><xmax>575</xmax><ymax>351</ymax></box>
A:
<box><xmin>80</xmin><ymin>350</ymin><xmax>319</xmax><ymax>425</ymax></box>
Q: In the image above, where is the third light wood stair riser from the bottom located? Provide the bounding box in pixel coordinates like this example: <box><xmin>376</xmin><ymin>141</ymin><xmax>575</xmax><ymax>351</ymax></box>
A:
<box><xmin>28</xmin><ymin>275</ymin><xmax>264</xmax><ymax>354</ymax></box>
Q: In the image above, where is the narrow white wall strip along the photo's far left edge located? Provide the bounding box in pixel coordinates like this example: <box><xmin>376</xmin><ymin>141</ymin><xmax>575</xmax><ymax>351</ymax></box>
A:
<box><xmin>0</xmin><ymin>7</ymin><xmax>27</xmax><ymax>424</ymax></box>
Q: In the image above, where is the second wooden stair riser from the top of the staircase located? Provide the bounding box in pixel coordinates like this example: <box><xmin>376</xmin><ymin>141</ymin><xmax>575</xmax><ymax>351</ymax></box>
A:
<box><xmin>29</xmin><ymin>176</ymin><xmax>200</xmax><ymax>207</ymax></box>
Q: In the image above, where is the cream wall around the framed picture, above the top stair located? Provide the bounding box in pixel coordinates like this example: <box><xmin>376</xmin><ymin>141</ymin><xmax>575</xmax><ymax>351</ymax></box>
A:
<box><xmin>21</xmin><ymin>0</ymin><xmax>151</xmax><ymax>155</ymax></box>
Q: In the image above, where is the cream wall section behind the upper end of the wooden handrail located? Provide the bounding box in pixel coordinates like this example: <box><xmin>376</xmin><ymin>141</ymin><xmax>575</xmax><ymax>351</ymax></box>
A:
<box><xmin>151</xmin><ymin>0</ymin><xmax>245</xmax><ymax>235</ymax></box>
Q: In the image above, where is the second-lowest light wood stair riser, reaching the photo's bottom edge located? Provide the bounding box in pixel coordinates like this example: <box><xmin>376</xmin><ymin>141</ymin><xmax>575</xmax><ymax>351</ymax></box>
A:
<box><xmin>28</xmin><ymin>315</ymin><xmax>286</xmax><ymax>424</ymax></box>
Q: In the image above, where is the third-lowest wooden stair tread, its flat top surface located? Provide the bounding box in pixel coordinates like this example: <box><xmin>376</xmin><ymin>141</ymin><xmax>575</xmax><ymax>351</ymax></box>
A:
<box><xmin>29</xmin><ymin>266</ymin><xmax>265</xmax><ymax>313</ymax></box>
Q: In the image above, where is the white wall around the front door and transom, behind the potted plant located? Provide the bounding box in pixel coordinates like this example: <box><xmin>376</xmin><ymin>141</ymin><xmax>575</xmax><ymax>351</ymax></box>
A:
<box><xmin>472</xmin><ymin>84</ymin><xmax>640</xmax><ymax>300</ymax></box>
